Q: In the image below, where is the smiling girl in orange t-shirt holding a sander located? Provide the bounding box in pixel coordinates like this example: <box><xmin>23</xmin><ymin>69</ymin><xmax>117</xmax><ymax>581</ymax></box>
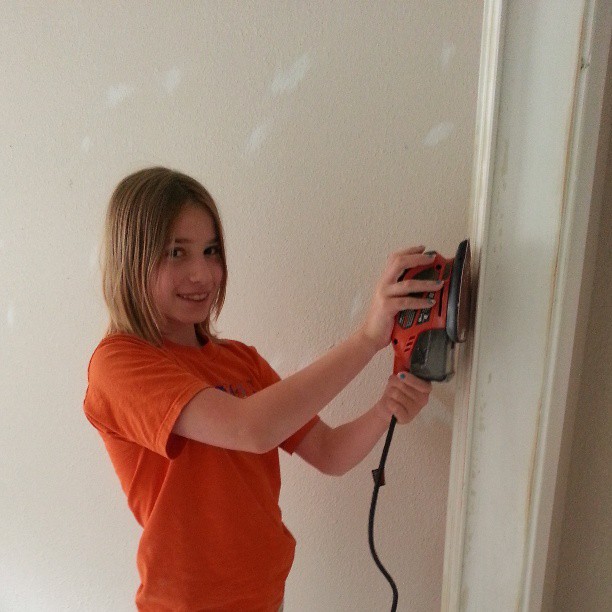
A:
<box><xmin>84</xmin><ymin>168</ymin><xmax>440</xmax><ymax>612</ymax></box>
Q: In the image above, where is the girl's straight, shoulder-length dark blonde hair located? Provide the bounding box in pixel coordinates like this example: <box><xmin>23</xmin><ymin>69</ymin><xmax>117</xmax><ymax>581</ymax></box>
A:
<box><xmin>102</xmin><ymin>167</ymin><xmax>227</xmax><ymax>346</ymax></box>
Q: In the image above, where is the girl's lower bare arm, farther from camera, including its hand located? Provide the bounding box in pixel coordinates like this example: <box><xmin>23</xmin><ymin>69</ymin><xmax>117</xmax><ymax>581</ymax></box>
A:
<box><xmin>295</xmin><ymin>373</ymin><xmax>431</xmax><ymax>476</ymax></box>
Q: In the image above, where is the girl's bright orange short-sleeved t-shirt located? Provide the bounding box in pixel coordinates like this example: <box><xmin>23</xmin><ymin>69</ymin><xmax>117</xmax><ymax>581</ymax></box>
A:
<box><xmin>84</xmin><ymin>334</ymin><xmax>317</xmax><ymax>612</ymax></box>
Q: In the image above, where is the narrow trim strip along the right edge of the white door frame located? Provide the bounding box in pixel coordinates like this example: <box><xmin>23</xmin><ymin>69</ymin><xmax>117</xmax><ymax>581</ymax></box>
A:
<box><xmin>522</xmin><ymin>0</ymin><xmax>612</xmax><ymax>610</ymax></box>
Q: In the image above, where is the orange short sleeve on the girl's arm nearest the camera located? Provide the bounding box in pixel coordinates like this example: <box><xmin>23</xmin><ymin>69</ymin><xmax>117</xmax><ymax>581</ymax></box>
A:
<box><xmin>84</xmin><ymin>336</ymin><xmax>209</xmax><ymax>459</ymax></box>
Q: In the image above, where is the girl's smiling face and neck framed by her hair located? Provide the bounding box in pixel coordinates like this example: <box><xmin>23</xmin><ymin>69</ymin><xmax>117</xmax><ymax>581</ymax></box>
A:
<box><xmin>151</xmin><ymin>204</ymin><xmax>223</xmax><ymax>346</ymax></box>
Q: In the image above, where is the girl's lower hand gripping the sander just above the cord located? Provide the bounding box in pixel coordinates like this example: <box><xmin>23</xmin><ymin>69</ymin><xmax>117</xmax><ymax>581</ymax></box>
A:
<box><xmin>375</xmin><ymin>372</ymin><xmax>432</xmax><ymax>424</ymax></box>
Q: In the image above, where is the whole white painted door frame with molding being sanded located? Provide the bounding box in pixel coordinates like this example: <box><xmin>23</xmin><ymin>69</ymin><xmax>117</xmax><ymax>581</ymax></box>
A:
<box><xmin>442</xmin><ymin>0</ymin><xmax>610</xmax><ymax>612</ymax></box>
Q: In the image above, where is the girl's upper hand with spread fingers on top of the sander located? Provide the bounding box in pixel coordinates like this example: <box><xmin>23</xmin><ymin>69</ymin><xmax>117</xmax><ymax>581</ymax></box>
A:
<box><xmin>360</xmin><ymin>246</ymin><xmax>441</xmax><ymax>351</ymax></box>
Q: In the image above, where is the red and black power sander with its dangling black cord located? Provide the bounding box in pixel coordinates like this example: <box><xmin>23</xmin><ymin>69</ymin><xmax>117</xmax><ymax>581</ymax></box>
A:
<box><xmin>368</xmin><ymin>240</ymin><xmax>471</xmax><ymax>612</ymax></box>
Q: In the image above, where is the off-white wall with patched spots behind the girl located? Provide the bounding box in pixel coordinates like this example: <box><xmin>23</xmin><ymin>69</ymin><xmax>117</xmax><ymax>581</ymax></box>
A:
<box><xmin>0</xmin><ymin>0</ymin><xmax>482</xmax><ymax>612</ymax></box>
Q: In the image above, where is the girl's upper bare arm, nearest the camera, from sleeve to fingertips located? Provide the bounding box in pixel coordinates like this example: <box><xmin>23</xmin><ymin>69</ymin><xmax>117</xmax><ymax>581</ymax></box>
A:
<box><xmin>173</xmin><ymin>247</ymin><xmax>440</xmax><ymax>453</ymax></box>
